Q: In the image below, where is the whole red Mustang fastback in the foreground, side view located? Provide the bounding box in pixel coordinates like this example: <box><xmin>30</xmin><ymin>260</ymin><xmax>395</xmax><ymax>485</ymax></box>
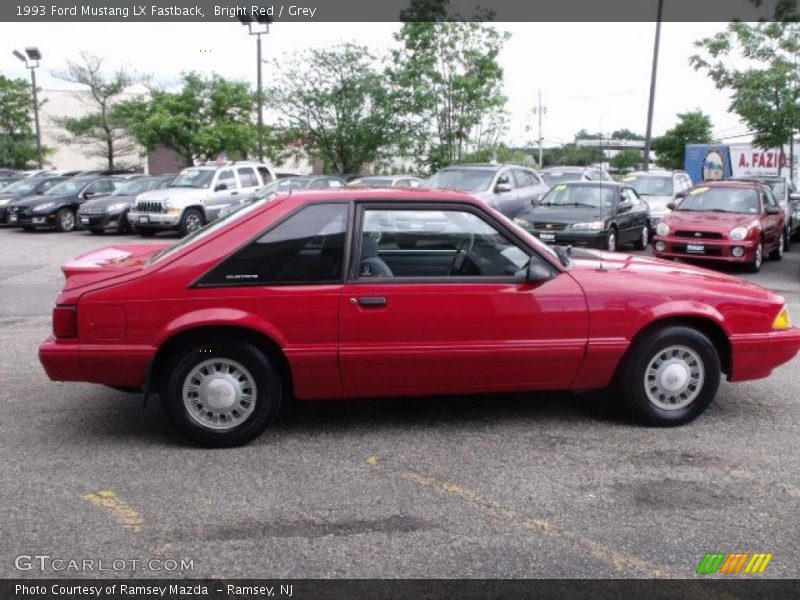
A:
<box><xmin>39</xmin><ymin>189</ymin><xmax>800</xmax><ymax>446</ymax></box>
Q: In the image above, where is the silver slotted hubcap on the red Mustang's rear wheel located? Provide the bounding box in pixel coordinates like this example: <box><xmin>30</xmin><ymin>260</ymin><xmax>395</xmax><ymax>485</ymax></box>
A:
<box><xmin>183</xmin><ymin>358</ymin><xmax>256</xmax><ymax>430</ymax></box>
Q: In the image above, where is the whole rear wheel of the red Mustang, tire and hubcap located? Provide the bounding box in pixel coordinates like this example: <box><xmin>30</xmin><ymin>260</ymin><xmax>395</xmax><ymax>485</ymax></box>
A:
<box><xmin>160</xmin><ymin>340</ymin><xmax>284</xmax><ymax>448</ymax></box>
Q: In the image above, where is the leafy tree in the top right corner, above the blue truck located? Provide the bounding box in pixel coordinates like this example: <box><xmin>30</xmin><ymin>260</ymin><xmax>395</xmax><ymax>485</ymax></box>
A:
<box><xmin>690</xmin><ymin>21</ymin><xmax>800</xmax><ymax>169</ymax></box>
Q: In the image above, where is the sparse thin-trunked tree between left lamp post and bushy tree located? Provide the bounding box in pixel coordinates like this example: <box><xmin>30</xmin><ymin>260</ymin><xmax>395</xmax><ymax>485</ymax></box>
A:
<box><xmin>54</xmin><ymin>53</ymin><xmax>142</xmax><ymax>169</ymax></box>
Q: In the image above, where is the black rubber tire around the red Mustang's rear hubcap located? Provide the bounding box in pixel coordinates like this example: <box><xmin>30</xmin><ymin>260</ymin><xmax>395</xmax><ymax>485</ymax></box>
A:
<box><xmin>161</xmin><ymin>341</ymin><xmax>283</xmax><ymax>448</ymax></box>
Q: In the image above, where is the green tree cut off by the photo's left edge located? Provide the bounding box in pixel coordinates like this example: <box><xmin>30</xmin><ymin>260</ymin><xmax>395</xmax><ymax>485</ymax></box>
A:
<box><xmin>0</xmin><ymin>75</ymin><xmax>36</xmax><ymax>169</ymax></box>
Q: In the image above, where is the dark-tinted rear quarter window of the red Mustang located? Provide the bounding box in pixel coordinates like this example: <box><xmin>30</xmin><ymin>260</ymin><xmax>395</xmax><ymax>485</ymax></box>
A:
<box><xmin>200</xmin><ymin>204</ymin><xmax>347</xmax><ymax>285</ymax></box>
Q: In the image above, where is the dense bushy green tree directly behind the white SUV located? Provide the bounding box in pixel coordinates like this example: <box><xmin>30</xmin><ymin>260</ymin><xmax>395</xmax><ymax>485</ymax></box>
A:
<box><xmin>118</xmin><ymin>72</ymin><xmax>257</xmax><ymax>164</ymax></box>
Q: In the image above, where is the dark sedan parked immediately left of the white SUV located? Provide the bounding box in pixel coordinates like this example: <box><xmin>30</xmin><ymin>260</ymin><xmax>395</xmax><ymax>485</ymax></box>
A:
<box><xmin>78</xmin><ymin>174</ymin><xmax>175</xmax><ymax>234</ymax></box>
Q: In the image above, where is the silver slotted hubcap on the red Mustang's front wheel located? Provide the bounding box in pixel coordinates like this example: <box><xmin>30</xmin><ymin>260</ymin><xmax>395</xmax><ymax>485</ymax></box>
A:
<box><xmin>644</xmin><ymin>346</ymin><xmax>705</xmax><ymax>410</ymax></box>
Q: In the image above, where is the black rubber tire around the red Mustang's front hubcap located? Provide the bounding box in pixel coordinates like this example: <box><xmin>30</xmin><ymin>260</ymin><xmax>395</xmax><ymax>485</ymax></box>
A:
<box><xmin>617</xmin><ymin>326</ymin><xmax>722</xmax><ymax>427</ymax></box>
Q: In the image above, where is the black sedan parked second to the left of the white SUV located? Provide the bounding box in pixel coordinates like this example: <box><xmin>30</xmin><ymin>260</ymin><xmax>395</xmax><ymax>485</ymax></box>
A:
<box><xmin>8</xmin><ymin>177</ymin><xmax>121</xmax><ymax>231</ymax></box>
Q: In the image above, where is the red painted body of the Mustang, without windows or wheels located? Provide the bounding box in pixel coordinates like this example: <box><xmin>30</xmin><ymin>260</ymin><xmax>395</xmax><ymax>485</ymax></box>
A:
<box><xmin>39</xmin><ymin>189</ymin><xmax>800</xmax><ymax>399</ymax></box>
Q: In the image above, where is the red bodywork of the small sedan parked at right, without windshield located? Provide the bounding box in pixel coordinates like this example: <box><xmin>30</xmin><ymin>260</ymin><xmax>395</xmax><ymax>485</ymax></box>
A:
<box><xmin>653</xmin><ymin>181</ymin><xmax>786</xmax><ymax>264</ymax></box>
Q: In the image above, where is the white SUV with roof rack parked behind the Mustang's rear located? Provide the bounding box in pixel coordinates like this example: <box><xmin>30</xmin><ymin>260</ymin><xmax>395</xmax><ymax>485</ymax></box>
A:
<box><xmin>128</xmin><ymin>162</ymin><xmax>275</xmax><ymax>237</ymax></box>
